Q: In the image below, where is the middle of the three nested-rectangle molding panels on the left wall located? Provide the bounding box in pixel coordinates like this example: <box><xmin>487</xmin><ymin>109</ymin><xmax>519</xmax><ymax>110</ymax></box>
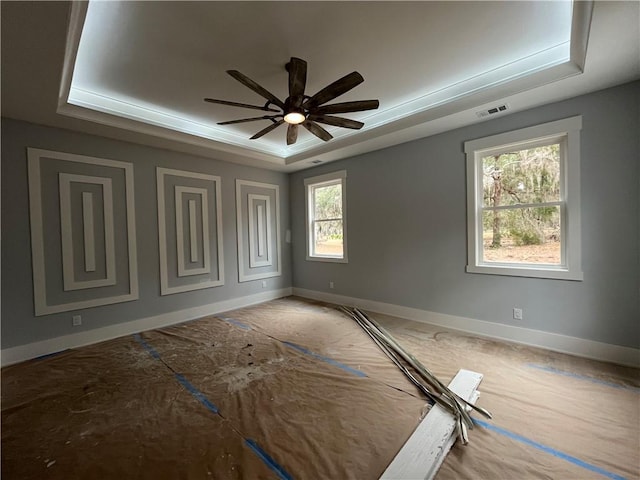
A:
<box><xmin>157</xmin><ymin>167</ymin><xmax>224</xmax><ymax>295</ymax></box>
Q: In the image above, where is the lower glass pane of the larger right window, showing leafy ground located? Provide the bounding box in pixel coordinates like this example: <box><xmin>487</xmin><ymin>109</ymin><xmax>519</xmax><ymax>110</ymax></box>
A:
<box><xmin>482</xmin><ymin>206</ymin><xmax>561</xmax><ymax>265</ymax></box>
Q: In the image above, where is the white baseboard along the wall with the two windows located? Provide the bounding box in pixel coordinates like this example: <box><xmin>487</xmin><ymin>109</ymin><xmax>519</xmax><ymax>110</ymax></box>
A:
<box><xmin>293</xmin><ymin>288</ymin><xmax>640</xmax><ymax>367</ymax></box>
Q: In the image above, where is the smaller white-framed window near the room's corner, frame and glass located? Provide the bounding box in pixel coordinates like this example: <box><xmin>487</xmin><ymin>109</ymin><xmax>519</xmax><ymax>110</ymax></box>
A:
<box><xmin>304</xmin><ymin>170</ymin><xmax>347</xmax><ymax>263</ymax></box>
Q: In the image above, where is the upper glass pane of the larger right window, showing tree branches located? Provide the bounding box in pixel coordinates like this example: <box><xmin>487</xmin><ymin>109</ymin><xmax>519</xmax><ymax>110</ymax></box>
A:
<box><xmin>482</xmin><ymin>143</ymin><xmax>560</xmax><ymax>207</ymax></box>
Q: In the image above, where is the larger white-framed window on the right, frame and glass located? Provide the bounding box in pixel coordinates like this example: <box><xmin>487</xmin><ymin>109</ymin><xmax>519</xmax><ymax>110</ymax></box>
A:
<box><xmin>465</xmin><ymin>117</ymin><xmax>582</xmax><ymax>280</ymax></box>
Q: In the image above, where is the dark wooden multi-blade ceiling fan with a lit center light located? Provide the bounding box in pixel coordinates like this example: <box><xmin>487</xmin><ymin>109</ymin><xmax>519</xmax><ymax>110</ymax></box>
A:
<box><xmin>204</xmin><ymin>57</ymin><xmax>380</xmax><ymax>145</ymax></box>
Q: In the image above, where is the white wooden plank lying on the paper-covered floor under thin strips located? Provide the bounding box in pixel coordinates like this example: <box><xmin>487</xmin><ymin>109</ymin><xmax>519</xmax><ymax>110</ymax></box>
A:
<box><xmin>380</xmin><ymin>369</ymin><xmax>482</xmax><ymax>480</ymax></box>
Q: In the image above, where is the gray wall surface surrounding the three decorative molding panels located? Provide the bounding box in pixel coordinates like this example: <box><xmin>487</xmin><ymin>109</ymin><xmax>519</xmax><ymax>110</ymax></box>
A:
<box><xmin>2</xmin><ymin>118</ymin><xmax>291</xmax><ymax>348</ymax></box>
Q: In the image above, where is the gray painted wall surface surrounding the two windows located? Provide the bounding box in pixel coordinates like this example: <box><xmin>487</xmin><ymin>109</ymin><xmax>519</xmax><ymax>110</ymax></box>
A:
<box><xmin>290</xmin><ymin>82</ymin><xmax>640</xmax><ymax>347</ymax></box>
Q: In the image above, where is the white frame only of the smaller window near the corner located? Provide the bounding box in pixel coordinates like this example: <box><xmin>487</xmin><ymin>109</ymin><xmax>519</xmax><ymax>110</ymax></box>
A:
<box><xmin>304</xmin><ymin>170</ymin><xmax>348</xmax><ymax>263</ymax></box>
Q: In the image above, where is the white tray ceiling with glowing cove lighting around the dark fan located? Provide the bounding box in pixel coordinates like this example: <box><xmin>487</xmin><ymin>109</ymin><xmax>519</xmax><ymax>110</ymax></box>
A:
<box><xmin>2</xmin><ymin>1</ymin><xmax>640</xmax><ymax>171</ymax></box>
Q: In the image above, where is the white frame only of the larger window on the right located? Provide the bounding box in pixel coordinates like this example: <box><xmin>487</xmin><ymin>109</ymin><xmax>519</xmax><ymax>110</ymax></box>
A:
<box><xmin>464</xmin><ymin>116</ymin><xmax>583</xmax><ymax>280</ymax></box>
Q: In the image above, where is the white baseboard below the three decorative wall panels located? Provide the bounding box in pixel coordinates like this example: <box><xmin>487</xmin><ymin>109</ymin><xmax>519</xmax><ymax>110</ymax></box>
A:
<box><xmin>0</xmin><ymin>287</ymin><xmax>292</xmax><ymax>367</ymax></box>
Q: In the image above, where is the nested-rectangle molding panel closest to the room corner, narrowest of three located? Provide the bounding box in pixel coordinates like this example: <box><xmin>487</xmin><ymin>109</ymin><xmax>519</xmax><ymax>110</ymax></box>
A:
<box><xmin>236</xmin><ymin>180</ymin><xmax>281</xmax><ymax>282</ymax></box>
